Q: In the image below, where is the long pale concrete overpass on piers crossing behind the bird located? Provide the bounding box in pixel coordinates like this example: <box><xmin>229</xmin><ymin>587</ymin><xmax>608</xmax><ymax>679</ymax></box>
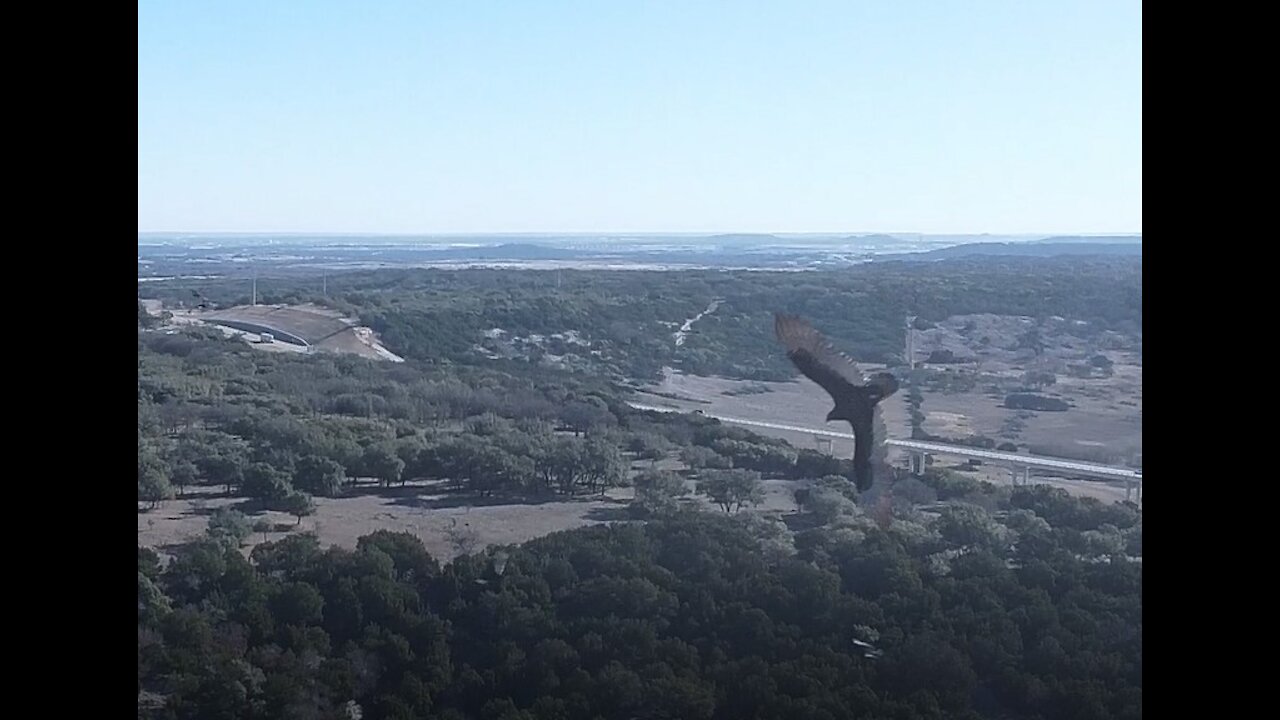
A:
<box><xmin>627</xmin><ymin>402</ymin><xmax>1142</xmax><ymax>505</ymax></box>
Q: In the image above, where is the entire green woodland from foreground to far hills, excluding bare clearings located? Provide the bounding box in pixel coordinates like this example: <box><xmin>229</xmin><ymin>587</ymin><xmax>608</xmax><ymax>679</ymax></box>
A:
<box><xmin>138</xmin><ymin>259</ymin><xmax>1142</xmax><ymax>720</ymax></box>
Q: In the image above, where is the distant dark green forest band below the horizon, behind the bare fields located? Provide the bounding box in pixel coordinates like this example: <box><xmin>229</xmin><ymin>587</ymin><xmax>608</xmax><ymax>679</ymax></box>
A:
<box><xmin>140</xmin><ymin>258</ymin><xmax>1142</xmax><ymax>380</ymax></box>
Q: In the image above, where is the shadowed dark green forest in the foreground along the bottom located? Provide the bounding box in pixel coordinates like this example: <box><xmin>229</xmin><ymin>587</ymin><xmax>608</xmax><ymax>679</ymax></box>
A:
<box><xmin>138</xmin><ymin>479</ymin><xmax>1142</xmax><ymax>720</ymax></box>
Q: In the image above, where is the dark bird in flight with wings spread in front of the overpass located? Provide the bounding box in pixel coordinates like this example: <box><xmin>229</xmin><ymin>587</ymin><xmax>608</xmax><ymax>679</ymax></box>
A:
<box><xmin>773</xmin><ymin>313</ymin><xmax>899</xmax><ymax>492</ymax></box>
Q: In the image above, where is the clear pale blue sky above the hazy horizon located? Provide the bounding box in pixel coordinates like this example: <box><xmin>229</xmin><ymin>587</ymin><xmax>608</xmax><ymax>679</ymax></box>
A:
<box><xmin>138</xmin><ymin>0</ymin><xmax>1142</xmax><ymax>233</ymax></box>
